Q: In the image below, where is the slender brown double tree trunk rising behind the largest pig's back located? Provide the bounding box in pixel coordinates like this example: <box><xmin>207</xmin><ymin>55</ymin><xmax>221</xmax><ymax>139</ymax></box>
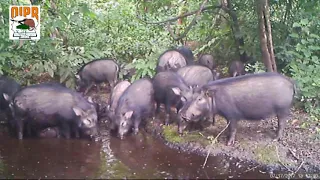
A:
<box><xmin>256</xmin><ymin>0</ymin><xmax>277</xmax><ymax>72</ymax></box>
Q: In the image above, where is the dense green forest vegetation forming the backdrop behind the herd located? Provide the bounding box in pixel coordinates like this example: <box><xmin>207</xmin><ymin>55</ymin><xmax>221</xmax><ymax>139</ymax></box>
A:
<box><xmin>0</xmin><ymin>0</ymin><xmax>320</xmax><ymax>120</ymax></box>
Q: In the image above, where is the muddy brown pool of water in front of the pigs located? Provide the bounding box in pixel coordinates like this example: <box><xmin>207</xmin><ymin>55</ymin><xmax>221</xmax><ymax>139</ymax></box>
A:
<box><xmin>0</xmin><ymin>125</ymin><xmax>269</xmax><ymax>179</ymax></box>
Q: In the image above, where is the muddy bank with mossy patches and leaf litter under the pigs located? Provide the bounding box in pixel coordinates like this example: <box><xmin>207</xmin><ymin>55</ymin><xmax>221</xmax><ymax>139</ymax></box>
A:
<box><xmin>89</xmin><ymin>85</ymin><xmax>320</xmax><ymax>173</ymax></box>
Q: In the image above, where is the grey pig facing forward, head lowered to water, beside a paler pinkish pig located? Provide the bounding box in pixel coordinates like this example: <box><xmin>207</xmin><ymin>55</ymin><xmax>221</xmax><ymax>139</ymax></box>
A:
<box><xmin>111</xmin><ymin>78</ymin><xmax>154</xmax><ymax>139</ymax></box>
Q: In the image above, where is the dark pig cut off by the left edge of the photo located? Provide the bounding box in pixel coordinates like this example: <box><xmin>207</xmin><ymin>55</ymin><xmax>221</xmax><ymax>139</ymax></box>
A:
<box><xmin>0</xmin><ymin>76</ymin><xmax>21</xmax><ymax>122</ymax></box>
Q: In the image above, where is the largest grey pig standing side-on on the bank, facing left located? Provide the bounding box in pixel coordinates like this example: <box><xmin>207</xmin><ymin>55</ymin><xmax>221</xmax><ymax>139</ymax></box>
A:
<box><xmin>179</xmin><ymin>73</ymin><xmax>295</xmax><ymax>145</ymax></box>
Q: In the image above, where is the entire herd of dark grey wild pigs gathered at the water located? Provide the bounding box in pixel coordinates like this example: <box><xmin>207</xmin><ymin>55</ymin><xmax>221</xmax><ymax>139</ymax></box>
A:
<box><xmin>0</xmin><ymin>46</ymin><xmax>295</xmax><ymax>145</ymax></box>
